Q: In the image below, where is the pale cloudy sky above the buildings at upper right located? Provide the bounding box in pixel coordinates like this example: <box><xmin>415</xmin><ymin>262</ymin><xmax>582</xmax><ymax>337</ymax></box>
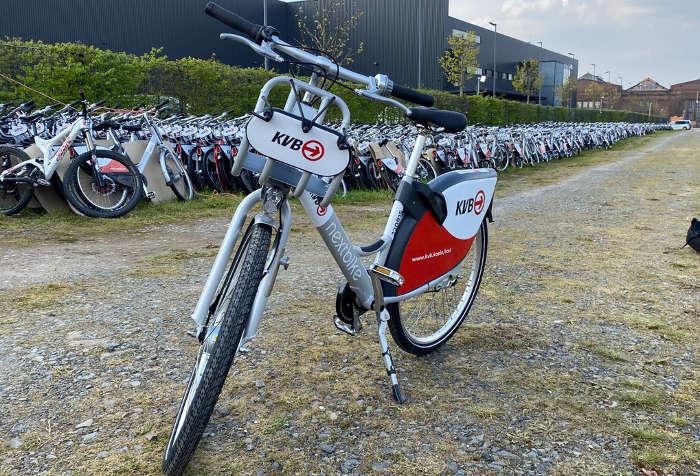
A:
<box><xmin>450</xmin><ymin>0</ymin><xmax>700</xmax><ymax>88</ymax></box>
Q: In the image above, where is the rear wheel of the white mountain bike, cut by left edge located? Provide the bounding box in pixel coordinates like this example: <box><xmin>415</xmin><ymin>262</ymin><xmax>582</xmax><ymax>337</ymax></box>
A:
<box><xmin>0</xmin><ymin>146</ymin><xmax>38</xmax><ymax>215</ymax></box>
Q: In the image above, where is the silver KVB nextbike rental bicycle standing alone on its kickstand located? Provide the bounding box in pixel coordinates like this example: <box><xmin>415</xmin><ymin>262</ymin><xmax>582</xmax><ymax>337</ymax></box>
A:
<box><xmin>163</xmin><ymin>3</ymin><xmax>496</xmax><ymax>474</ymax></box>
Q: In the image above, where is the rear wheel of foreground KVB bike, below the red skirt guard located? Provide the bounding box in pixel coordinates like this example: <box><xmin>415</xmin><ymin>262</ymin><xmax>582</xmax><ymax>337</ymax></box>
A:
<box><xmin>387</xmin><ymin>220</ymin><xmax>488</xmax><ymax>355</ymax></box>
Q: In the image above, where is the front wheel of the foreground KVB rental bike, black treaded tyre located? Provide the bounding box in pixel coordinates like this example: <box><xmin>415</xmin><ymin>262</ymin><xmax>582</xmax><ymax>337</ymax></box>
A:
<box><xmin>163</xmin><ymin>224</ymin><xmax>272</xmax><ymax>475</ymax></box>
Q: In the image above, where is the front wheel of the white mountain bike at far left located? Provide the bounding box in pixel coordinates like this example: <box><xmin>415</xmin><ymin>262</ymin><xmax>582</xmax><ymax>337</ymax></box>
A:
<box><xmin>63</xmin><ymin>149</ymin><xmax>143</xmax><ymax>218</ymax></box>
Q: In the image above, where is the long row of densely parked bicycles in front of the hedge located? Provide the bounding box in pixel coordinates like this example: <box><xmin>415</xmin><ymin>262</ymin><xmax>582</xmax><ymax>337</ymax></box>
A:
<box><xmin>0</xmin><ymin>97</ymin><xmax>668</xmax><ymax>218</ymax></box>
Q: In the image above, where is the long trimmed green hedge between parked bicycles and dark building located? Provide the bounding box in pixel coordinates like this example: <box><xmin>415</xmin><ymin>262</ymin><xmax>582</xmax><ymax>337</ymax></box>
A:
<box><xmin>0</xmin><ymin>40</ymin><xmax>665</xmax><ymax>125</ymax></box>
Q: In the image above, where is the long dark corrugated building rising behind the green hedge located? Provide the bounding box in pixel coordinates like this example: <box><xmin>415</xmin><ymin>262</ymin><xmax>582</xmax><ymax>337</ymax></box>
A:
<box><xmin>0</xmin><ymin>0</ymin><xmax>578</xmax><ymax>105</ymax></box>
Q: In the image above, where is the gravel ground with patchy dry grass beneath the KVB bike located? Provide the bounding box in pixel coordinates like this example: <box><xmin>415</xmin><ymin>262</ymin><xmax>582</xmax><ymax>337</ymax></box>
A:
<box><xmin>0</xmin><ymin>132</ymin><xmax>700</xmax><ymax>474</ymax></box>
